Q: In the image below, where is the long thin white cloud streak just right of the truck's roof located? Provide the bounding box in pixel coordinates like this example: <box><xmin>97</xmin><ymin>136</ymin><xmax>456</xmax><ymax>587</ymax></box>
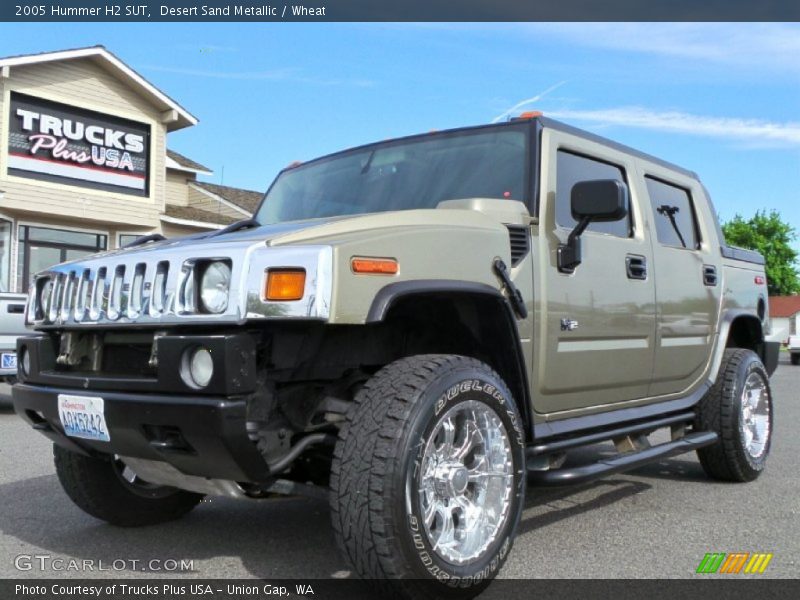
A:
<box><xmin>545</xmin><ymin>106</ymin><xmax>800</xmax><ymax>147</ymax></box>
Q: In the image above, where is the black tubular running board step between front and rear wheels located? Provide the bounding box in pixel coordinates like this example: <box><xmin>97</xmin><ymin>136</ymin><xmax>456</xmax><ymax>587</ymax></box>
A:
<box><xmin>528</xmin><ymin>431</ymin><xmax>718</xmax><ymax>485</ymax></box>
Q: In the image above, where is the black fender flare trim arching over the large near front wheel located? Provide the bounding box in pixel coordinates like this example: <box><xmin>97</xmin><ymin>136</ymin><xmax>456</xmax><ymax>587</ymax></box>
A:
<box><xmin>366</xmin><ymin>279</ymin><xmax>533</xmax><ymax>440</ymax></box>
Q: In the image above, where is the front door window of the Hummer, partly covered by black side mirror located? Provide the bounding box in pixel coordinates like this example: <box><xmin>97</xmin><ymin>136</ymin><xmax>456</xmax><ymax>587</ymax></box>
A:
<box><xmin>556</xmin><ymin>150</ymin><xmax>632</xmax><ymax>237</ymax></box>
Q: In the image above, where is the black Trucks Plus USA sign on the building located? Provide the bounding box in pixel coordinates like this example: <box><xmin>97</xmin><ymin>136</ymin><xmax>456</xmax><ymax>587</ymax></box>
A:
<box><xmin>8</xmin><ymin>93</ymin><xmax>150</xmax><ymax>196</ymax></box>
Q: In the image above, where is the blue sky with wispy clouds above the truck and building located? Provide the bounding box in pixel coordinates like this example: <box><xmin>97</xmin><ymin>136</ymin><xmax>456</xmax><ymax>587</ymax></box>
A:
<box><xmin>0</xmin><ymin>23</ymin><xmax>800</xmax><ymax>239</ymax></box>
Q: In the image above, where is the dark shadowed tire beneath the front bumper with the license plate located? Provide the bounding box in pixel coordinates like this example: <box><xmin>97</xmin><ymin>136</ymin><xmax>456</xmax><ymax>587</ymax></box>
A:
<box><xmin>53</xmin><ymin>444</ymin><xmax>203</xmax><ymax>527</ymax></box>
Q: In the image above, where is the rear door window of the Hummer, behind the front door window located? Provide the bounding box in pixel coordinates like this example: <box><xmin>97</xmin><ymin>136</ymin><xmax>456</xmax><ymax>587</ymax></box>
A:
<box><xmin>645</xmin><ymin>177</ymin><xmax>700</xmax><ymax>250</ymax></box>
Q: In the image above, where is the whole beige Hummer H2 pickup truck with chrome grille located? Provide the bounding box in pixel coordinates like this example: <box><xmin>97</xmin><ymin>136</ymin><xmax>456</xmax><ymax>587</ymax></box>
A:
<box><xmin>14</xmin><ymin>115</ymin><xmax>778</xmax><ymax>597</ymax></box>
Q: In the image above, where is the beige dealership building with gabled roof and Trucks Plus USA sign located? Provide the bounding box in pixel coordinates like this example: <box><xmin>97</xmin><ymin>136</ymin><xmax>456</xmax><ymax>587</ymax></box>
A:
<box><xmin>0</xmin><ymin>46</ymin><xmax>262</xmax><ymax>292</ymax></box>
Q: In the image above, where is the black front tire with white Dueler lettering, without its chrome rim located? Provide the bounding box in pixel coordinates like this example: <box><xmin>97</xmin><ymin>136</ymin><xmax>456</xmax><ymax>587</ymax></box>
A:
<box><xmin>330</xmin><ymin>355</ymin><xmax>525</xmax><ymax>598</ymax></box>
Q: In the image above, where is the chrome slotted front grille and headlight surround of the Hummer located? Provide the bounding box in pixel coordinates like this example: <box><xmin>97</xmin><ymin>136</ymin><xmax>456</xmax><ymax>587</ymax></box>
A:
<box><xmin>26</xmin><ymin>241</ymin><xmax>332</xmax><ymax>329</ymax></box>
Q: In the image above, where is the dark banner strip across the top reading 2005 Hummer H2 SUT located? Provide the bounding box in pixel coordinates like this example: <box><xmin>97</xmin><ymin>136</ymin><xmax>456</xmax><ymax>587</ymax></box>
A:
<box><xmin>0</xmin><ymin>0</ymin><xmax>800</xmax><ymax>22</ymax></box>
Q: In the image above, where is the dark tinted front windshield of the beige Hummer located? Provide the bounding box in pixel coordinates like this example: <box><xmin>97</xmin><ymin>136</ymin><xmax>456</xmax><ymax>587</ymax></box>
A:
<box><xmin>256</xmin><ymin>125</ymin><xmax>528</xmax><ymax>225</ymax></box>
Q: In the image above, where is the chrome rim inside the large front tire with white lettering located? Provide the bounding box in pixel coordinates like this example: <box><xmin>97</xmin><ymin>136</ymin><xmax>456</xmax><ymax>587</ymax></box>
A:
<box><xmin>417</xmin><ymin>400</ymin><xmax>514</xmax><ymax>564</ymax></box>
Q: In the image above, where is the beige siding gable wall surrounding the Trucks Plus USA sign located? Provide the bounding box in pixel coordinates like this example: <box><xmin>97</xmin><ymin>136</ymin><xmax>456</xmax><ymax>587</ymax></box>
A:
<box><xmin>0</xmin><ymin>58</ymin><xmax>166</xmax><ymax>229</ymax></box>
